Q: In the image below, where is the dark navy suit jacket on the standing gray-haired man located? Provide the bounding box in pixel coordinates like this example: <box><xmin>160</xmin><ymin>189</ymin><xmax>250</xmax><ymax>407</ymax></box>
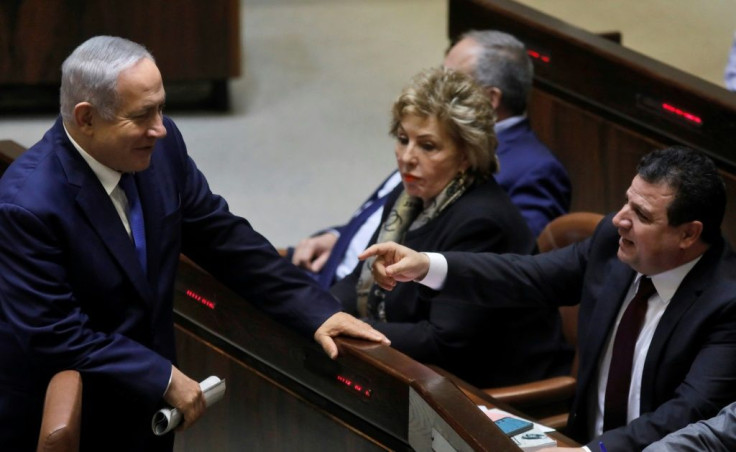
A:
<box><xmin>0</xmin><ymin>118</ymin><xmax>340</xmax><ymax>450</ymax></box>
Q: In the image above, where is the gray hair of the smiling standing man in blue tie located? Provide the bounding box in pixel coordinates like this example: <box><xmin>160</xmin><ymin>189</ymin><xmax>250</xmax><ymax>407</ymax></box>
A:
<box><xmin>59</xmin><ymin>36</ymin><xmax>155</xmax><ymax>122</ymax></box>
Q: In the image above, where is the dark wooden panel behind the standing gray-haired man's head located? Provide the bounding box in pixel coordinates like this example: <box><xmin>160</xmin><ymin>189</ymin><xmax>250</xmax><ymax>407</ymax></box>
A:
<box><xmin>0</xmin><ymin>0</ymin><xmax>240</xmax><ymax>85</ymax></box>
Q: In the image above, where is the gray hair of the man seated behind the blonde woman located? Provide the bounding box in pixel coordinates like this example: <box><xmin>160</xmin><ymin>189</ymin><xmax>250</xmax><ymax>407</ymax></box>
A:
<box><xmin>461</xmin><ymin>30</ymin><xmax>534</xmax><ymax>115</ymax></box>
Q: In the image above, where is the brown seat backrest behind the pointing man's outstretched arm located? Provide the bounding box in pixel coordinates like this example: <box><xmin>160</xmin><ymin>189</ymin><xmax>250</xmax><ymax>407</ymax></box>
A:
<box><xmin>537</xmin><ymin>212</ymin><xmax>603</xmax><ymax>377</ymax></box>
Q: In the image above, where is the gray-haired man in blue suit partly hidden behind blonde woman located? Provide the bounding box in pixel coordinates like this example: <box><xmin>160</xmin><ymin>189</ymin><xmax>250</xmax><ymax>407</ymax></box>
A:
<box><xmin>291</xmin><ymin>30</ymin><xmax>571</xmax><ymax>288</ymax></box>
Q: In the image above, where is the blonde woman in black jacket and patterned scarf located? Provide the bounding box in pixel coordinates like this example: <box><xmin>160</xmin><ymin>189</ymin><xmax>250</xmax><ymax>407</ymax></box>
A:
<box><xmin>331</xmin><ymin>67</ymin><xmax>571</xmax><ymax>387</ymax></box>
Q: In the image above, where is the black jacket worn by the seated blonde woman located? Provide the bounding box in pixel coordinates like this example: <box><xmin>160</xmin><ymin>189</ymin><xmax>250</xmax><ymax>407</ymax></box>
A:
<box><xmin>331</xmin><ymin>179</ymin><xmax>572</xmax><ymax>387</ymax></box>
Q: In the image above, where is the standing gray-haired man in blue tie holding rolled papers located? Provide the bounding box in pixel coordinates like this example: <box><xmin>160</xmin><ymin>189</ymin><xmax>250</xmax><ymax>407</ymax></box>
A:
<box><xmin>0</xmin><ymin>36</ymin><xmax>387</xmax><ymax>451</ymax></box>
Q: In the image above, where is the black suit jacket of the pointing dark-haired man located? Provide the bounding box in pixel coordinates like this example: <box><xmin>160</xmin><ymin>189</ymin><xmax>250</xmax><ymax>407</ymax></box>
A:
<box><xmin>436</xmin><ymin>216</ymin><xmax>736</xmax><ymax>450</ymax></box>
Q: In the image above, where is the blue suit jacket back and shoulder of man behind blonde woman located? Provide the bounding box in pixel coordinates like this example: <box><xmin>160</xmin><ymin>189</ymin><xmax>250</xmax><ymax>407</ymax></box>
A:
<box><xmin>496</xmin><ymin>119</ymin><xmax>570</xmax><ymax>237</ymax></box>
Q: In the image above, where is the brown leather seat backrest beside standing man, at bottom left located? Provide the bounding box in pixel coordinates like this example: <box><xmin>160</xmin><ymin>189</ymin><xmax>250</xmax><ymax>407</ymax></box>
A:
<box><xmin>37</xmin><ymin>370</ymin><xmax>82</xmax><ymax>452</ymax></box>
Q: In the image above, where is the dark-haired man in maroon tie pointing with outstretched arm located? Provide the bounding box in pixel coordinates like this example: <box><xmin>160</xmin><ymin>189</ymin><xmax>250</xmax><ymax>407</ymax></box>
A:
<box><xmin>361</xmin><ymin>147</ymin><xmax>736</xmax><ymax>451</ymax></box>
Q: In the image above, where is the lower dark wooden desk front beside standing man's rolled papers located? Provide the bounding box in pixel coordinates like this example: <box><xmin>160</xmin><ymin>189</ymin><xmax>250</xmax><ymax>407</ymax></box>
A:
<box><xmin>175</xmin><ymin>327</ymin><xmax>389</xmax><ymax>451</ymax></box>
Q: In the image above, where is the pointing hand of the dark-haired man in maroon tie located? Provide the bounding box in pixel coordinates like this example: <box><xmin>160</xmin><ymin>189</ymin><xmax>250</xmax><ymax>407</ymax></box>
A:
<box><xmin>358</xmin><ymin>242</ymin><xmax>429</xmax><ymax>290</ymax></box>
